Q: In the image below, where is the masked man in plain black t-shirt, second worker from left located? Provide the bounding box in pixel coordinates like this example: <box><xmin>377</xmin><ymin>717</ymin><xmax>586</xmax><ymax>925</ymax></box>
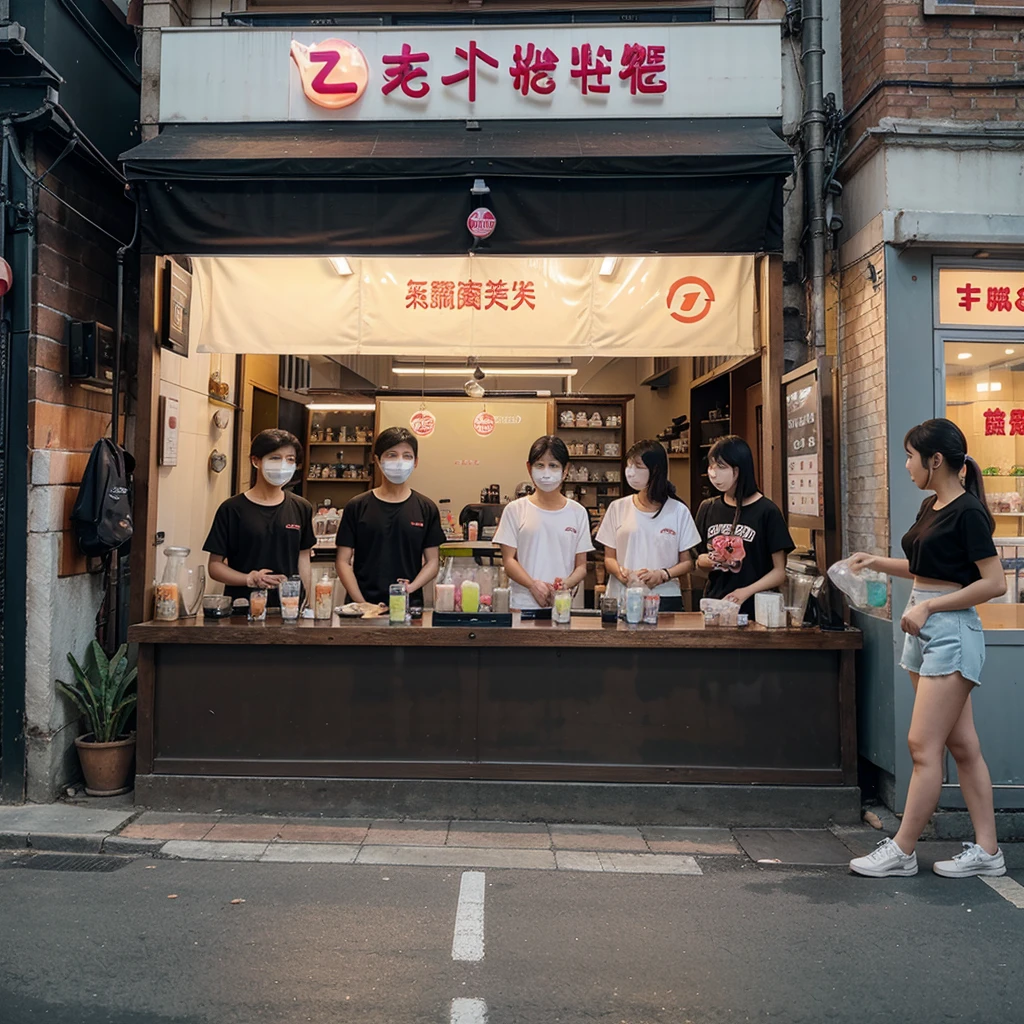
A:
<box><xmin>335</xmin><ymin>427</ymin><xmax>444</xmax><ymax>607</ymax></box>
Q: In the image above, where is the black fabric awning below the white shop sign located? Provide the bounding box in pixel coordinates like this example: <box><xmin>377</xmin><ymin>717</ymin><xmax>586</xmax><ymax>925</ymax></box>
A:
<box><xmin>122</xmin><ymin>119</ymin><xmax>793</xmax><ymax>255</ymax></box>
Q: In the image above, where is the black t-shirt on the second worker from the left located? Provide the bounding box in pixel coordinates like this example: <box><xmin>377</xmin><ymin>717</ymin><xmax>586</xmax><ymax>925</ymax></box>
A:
<box><xmin>335</xmin><ymin>490</ymin><xmax>444</xmax><ymax>605</ymax></box>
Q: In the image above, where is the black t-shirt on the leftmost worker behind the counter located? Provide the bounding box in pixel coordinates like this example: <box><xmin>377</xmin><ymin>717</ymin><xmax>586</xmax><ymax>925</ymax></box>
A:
<box><xmin>203</xmin><ymin>490</ymin><xmax>316</xmax><ymax>604</ymax></box>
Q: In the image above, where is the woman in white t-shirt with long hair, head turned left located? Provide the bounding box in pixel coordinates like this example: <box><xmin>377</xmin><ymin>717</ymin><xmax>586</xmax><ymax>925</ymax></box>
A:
<box><xmin>597</xmin><ymin>440</ymin><xmax>700</xmax><ymax>611</ymax></box>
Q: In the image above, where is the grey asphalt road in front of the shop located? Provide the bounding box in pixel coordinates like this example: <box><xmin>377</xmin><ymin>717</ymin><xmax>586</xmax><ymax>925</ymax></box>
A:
<box><xmin>0</xmin><ymin>858</ymin><xmax>1024</xmax><ymax>1024</ymax></box>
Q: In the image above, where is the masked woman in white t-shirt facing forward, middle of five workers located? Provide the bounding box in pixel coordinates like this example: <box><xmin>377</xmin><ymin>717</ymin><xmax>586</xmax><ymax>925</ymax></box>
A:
<box><xmin>495</xmin><ymin>434</ymin><xmax>594</xmax><ymax>609</ymax></box>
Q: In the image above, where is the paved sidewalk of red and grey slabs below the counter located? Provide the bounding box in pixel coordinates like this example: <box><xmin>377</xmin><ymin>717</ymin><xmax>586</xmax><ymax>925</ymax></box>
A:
<box><xmin>6</xmin><ymin>804</ymin><xmax>1024</xmax><ymax>874</ymax></box>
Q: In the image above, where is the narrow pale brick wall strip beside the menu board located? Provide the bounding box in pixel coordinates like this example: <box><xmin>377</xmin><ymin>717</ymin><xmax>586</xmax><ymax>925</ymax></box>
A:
<box><xmin>839</xmin><ymin>252</ymin><xmax>889</xmax><ymax>556</ymax></box>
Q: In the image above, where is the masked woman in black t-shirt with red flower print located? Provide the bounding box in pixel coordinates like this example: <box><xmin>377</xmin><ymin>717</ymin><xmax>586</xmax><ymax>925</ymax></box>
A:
<box><xmin>697</xmin><ymin>434</ymin><xmax>796</xmax><ymax>615</ymax></box>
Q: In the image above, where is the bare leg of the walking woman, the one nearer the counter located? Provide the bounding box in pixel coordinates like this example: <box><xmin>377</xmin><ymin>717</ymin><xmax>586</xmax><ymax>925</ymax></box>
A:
<box><xmin>895</xmin><ymin>672</ymin><xmax>971</xmax><ymax>854</ymax></box>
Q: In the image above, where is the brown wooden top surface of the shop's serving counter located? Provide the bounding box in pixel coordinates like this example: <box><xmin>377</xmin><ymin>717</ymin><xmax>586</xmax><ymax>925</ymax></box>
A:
<box><xmin>128</xmin><ymin>611</ymin><xmax>862</xmax><ymax>650</ymax></box>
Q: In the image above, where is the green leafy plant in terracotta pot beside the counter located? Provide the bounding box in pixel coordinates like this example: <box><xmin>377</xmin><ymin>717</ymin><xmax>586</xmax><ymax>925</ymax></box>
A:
<box><xmin>57</xmin><ymin>640</ymin><xmax>138</xmax><ymax>797</ymax></box>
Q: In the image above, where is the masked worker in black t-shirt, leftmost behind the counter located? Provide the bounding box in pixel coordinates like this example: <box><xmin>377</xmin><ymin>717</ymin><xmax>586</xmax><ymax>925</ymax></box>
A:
<box><xmin>203</xmin><ymin>429</ymin><xmax>316</xmax><ymax>604</ymax></box>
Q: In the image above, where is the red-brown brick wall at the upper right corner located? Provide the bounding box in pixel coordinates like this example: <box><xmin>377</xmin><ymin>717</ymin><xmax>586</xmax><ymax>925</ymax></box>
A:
<box><xmin>842</xmin><ymin>0</ymin><xmax>1024</xmax><ymax>158</ymax></box>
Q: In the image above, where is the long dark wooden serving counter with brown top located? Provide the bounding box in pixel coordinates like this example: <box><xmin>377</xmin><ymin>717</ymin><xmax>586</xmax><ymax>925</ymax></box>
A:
<box><xmin>129</xmin><ymin>613</ymin><xmax>861</xmax><ymax>786</ymax></box>
